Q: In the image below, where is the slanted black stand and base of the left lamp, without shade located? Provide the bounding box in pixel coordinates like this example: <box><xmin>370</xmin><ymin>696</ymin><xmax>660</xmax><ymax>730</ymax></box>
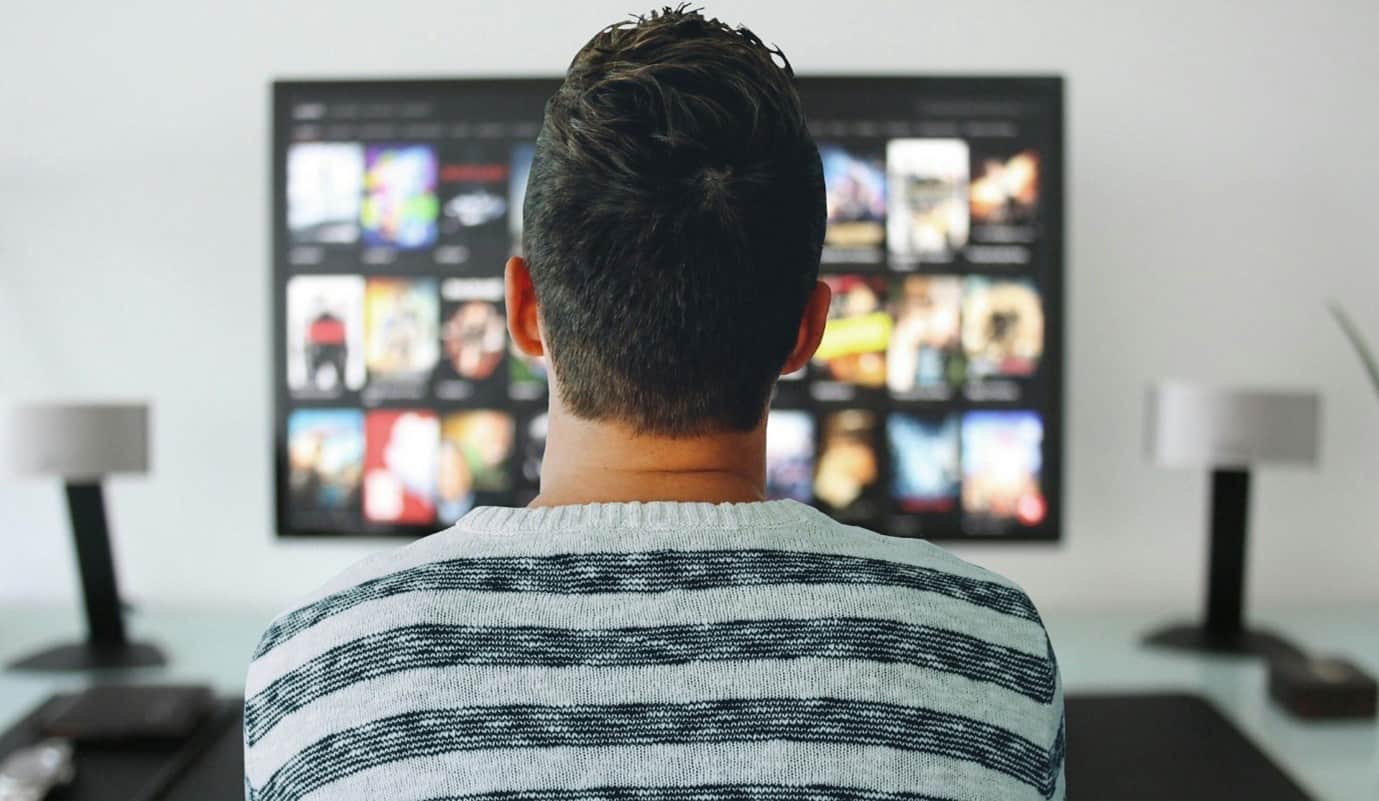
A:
<box><xmin>10</xmin><ymin>481</ymin><xmax>165</xmax><ymax>670</ymax></box>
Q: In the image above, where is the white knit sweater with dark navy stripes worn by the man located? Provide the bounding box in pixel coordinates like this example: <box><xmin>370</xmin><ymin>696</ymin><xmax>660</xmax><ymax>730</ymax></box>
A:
<box><xmin>244</xmin><ymin>500</ymin><xmax>1065</xmax><ymax>801</ymax></box>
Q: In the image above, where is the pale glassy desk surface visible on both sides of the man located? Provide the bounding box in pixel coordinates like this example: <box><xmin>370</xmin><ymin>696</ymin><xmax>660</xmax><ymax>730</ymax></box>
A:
<box><xmin>0</xmin><ymin>607</ymin><xmax>1379</xmax><ymax>801</ymax></box>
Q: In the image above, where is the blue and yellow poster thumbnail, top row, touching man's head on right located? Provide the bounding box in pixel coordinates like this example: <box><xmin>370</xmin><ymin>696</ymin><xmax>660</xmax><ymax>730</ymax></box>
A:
<box><xmin>819</xmin><ymin>145</ymin><xmax>885</xmax><ymax>265</ymax></box>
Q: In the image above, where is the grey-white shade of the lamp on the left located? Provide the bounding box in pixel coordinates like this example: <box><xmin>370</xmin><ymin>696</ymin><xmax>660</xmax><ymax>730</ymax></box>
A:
<box><xmin>0</xmin><ymin>403</ymin><xmax>149</xmax><ymax>481</ymax></box>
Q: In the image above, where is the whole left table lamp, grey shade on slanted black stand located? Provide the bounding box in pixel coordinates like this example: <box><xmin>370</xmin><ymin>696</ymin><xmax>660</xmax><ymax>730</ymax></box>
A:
<box><xmin>0</xmin><ymin>404</ymin><xmax>164</xmax><ymax>670</ymax></box>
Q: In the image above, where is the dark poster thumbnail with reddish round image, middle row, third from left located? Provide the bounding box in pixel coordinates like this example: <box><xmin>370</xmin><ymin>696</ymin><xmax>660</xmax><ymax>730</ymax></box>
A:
<box><xmin>436</xmin><ymin>278</ymin><xmax>507</xmax><ymax>401</ymax></box>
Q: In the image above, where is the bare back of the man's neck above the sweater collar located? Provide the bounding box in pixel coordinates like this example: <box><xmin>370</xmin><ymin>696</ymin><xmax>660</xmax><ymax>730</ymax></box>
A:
<box><xmin>531</xmin><ymin>408</ymin><xmax>765</xmax><ymax>506</ymax></box>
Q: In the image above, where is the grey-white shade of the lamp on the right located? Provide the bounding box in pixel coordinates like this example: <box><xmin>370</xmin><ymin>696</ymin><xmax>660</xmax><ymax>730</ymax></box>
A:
<box><xmin>1145</xmin><ymin>382</ymin><xmax>1321</xmax><ymax>469</ymax></box>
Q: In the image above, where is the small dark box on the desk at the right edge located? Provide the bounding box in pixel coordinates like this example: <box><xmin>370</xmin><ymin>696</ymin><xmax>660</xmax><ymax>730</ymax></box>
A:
<box><xmin>1269</xmin><ymin>658</ymin><xmax>1379</xmax><ymax>720</ymax></box>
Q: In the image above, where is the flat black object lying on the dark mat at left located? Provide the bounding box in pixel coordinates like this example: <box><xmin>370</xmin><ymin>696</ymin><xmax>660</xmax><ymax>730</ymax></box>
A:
<box><xmin>40</xmin><ymin>685</ymin><xmax>215</xmax><ymax>742</ymax></box>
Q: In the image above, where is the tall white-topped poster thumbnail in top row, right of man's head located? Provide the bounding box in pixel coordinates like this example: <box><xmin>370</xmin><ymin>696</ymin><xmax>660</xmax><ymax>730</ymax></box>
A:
<box><xmin>885</xmin><ymin>139</ymin><xmax>971</xmax><ymax>261</ymax></box>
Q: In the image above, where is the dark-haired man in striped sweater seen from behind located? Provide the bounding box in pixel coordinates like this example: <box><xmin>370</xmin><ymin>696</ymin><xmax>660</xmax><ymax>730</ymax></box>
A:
<box><xmin>245</xmin><ymin>10</ymin><xmax>1065</xmax><ymax>801</ymax></box>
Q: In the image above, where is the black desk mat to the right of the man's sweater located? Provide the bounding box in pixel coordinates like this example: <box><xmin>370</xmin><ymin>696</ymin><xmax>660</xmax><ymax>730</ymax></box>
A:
<box><xmin>1065</xmin><ymin>695</ymin><xmax>1311</xmax><ymax>801</ymax></box>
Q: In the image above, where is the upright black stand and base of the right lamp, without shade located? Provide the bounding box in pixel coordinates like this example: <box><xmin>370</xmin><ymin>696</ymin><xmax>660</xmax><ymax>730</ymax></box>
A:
<box><xmin>1145</xmin><ymin>470</ymin><xmax>1300</xmax><ymax>658</ymax></box>
